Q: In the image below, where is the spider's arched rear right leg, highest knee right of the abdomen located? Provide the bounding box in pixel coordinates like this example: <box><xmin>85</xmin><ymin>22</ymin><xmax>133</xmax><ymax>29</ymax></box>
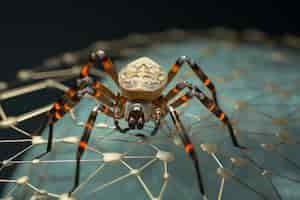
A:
<box><xmin>168</xmin><ymin>56</ymin><xmax>218</xmax><ymax>105</ymax></box>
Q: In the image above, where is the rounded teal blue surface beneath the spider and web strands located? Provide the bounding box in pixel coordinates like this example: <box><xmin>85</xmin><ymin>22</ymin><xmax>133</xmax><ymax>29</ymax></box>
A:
<box><xmin>0</xmin><ymin>36</ymin><xmax>300</xmax><ymax>200</ymax></box>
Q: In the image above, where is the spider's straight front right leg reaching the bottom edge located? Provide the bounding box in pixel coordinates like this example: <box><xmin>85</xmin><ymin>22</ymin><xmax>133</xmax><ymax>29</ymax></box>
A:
<box><xmin>169</xmin><ymin>106</ymin><xmax>207</xmax><ymax>200</ymax></box>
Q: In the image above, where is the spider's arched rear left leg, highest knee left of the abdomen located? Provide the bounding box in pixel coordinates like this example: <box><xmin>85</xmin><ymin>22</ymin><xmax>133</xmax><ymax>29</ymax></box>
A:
<box><xmin>80</xmin><ymin>50</ymin><xmax>119</xmax><ymax>85</ymax></box>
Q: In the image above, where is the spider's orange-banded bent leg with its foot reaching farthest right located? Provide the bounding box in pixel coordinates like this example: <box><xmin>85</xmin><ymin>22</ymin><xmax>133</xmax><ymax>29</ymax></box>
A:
<box><xmin>170</xmin><ymin>86</ymin><xmax>247</xmax><ymax>150</ymax></box>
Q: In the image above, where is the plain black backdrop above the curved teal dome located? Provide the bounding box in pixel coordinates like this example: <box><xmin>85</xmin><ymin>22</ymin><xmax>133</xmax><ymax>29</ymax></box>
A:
<box><xmin>0</xmin><ymin>0</ymin><xmax>300</xmax><ymax>80</ymax></box>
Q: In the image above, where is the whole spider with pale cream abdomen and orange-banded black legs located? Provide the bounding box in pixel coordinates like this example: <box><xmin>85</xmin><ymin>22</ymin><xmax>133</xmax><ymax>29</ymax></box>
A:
<box><xmin>36</xmin><ymin>50</ymin><xmax>246</xmax><ymax>199</ymax></box>
